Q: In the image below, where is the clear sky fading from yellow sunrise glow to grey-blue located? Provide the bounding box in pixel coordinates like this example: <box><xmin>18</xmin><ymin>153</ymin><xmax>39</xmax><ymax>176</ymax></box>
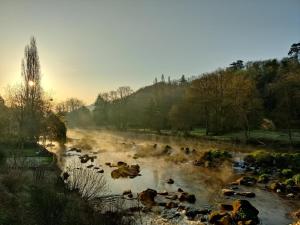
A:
<box><xmin>0</xmin><ymin>0</ymin><xmax>300</xmax><ymax>104</ymax></box>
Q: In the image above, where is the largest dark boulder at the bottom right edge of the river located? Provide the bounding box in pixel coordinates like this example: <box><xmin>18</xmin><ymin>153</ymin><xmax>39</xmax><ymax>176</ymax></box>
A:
<box><xmin>232</xmin><ymin>200</ymin><xmax>259</xmax><ymax>224</ymax></box>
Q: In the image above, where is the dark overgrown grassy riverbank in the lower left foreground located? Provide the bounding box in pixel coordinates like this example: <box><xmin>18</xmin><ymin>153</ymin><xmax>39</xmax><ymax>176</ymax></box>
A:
<box><xmin>0</xmin><ymin>144</ymin><xmax>138</xmax><ymax>225</ymax></box>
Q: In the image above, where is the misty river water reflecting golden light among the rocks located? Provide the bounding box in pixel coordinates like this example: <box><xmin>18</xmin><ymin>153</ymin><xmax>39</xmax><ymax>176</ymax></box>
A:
<box><xmin>50</xmin><ymin>129</ymin><xmax>296</xmax><ymax>225</ymax></box>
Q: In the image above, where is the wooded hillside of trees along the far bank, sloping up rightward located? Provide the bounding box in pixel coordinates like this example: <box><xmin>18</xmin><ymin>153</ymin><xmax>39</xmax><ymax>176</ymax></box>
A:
<box><xmin>56</xmin><ymin>43</ymin><xmax>300</xmax><ymax>144</ymax></box>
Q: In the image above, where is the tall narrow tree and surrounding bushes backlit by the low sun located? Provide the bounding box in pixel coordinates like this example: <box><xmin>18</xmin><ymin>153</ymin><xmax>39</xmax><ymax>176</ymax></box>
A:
<box><xmin>0</xmin><ymin>37</ymin><xmax>66</xmax><ymax>148</ymax></box>
